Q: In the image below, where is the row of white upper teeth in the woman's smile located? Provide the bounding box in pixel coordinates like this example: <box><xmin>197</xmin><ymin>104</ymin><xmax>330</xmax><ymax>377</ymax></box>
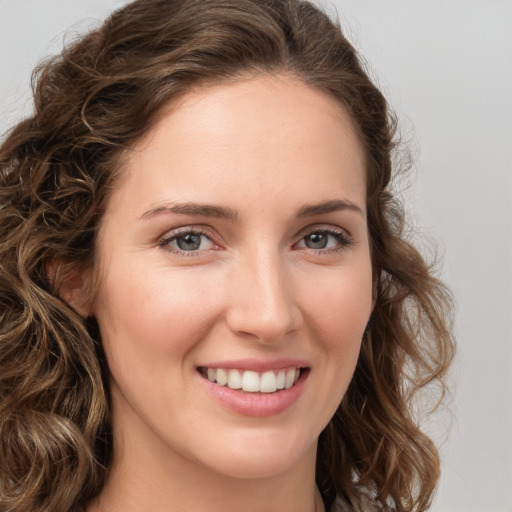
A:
<box><xmin>206</xmin><ymin>368</ymin><xmax>300</xmax><ymax>393</ymax></box>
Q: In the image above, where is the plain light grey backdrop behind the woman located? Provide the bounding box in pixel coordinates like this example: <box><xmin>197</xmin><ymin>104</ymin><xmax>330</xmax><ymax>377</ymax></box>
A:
<box><xmin>0</xmin><ymin>0</ymin><xmax>512</xmax><ymax>512</ymax></box>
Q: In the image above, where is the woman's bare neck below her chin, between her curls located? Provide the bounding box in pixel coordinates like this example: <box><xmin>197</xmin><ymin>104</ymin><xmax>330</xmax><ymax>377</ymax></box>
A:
<box><xmin>87</xmin><ymin>432</ymin><xmax>324</xmax><ymax>512</ymax></box>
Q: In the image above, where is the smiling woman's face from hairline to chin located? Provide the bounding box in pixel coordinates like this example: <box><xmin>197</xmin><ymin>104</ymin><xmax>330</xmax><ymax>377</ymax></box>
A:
<box><xmin>88</xmin><ymin>77</ymin><xmax>372</xmax><ymax>477</ymax></box>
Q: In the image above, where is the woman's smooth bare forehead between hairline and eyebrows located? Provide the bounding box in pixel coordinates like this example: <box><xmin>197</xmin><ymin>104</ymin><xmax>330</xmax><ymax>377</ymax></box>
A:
<box><xmin>111</xmin><ymin>75</ymin><xmax>365</xmax><ymax>218</ymax></box>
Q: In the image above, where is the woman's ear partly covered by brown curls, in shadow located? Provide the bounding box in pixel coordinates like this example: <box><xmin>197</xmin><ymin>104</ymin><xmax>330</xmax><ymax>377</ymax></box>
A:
<box><xmin>46</xmin><ymin>258</ymin><xmax>92</xmax><ymax>318</ymax></box>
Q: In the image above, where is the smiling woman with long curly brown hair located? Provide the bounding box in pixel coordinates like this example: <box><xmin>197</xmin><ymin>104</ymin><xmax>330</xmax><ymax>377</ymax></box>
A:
<box><xmin>0</xmin><ymin>0</ymin><xmax>453</xmax><ymax>512</ymax></box>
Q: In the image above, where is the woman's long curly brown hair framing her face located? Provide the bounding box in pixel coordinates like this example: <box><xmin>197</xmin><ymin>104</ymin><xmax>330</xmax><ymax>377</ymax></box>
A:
<box><xmin>0</xmin><ymin>0</ymin><xmax>454</xmax><ymax>512</ymax></box>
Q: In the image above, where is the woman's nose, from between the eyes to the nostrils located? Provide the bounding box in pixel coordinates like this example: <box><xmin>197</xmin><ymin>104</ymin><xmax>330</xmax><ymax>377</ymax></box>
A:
<box><xmin>226</xmin><ymin>251</ymin><xmax>303</xmax><ymax>344</ymax></box>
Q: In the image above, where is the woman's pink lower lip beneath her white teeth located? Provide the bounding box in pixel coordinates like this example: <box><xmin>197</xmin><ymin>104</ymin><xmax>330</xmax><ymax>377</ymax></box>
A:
<box><xmin>199</xmin><ymin>371</ymin><xmax>309</xmax><ymax>416</ymax></box>
